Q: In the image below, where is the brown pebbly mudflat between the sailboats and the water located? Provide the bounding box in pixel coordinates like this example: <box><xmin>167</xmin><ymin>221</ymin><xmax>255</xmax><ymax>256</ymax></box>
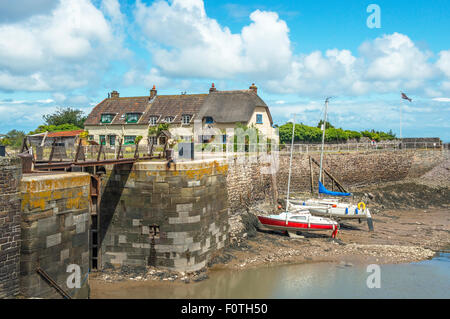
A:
<box><xmin>90</xmin><ymin>209</ymin><xmax>450</xmax><ymax>298</ymax></box>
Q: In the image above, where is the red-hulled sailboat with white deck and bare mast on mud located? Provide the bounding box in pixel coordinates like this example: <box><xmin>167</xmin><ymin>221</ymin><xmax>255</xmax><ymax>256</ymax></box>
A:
<box><xmin>257</xmin><ymin>114</ymin><xmax>339</xmax><ymax>238</ymax></box>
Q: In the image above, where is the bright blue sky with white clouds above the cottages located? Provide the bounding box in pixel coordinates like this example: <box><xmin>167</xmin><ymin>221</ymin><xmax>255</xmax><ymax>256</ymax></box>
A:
<box><xmin>0</xmin><ymin>0</ymin><xmax>450</xmax><ymax>142</ymax></box>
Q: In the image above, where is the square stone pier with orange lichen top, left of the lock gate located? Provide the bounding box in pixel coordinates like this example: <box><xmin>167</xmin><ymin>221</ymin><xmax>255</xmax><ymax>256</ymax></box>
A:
<box><xmin>20</xmin><ymin>172</ymin><xmax>90</xmax><ymax>298</ymax></box>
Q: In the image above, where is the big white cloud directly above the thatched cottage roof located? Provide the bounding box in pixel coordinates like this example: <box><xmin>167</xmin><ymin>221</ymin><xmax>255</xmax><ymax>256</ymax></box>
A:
<box><xmin>135</xmin><ymin>0</ymin><xmax>292</xmax><ymax>79</ymax></box>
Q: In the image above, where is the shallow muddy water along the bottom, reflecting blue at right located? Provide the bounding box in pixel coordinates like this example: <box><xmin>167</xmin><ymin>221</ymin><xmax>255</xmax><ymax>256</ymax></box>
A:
<box><xmin>92</xmin><ymin>253</ymin><xmax>450</xmax><ymax>298</ymax></box>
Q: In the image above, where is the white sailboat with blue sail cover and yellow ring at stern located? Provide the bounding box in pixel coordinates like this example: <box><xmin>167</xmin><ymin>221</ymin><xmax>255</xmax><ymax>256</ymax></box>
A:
<box><xmin>286</xmin><ymin>97</ymin><xmax>373</xmax><ymax>231</ymax></box>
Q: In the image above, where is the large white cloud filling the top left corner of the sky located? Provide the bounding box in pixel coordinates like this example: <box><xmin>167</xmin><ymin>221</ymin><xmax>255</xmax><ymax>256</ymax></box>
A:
<box><xmin>0</xmin><ymin>0</ymin><xmax>121</xmax><ymax>91</ymax></box>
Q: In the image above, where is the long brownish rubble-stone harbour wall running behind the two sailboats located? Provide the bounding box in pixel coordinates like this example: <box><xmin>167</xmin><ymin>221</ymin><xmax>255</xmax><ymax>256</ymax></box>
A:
<box><xmin>223</xmin><ymin>150</ymin><xmax>449</xmax><ymax>214</ymax></box>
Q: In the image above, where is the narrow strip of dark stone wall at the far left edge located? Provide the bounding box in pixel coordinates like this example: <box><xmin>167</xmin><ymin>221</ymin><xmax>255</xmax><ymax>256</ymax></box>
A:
<box><xmin>0</xmin><ymin>157</ymin><xmax>22</xmax><ymax>299</ymax></box>
